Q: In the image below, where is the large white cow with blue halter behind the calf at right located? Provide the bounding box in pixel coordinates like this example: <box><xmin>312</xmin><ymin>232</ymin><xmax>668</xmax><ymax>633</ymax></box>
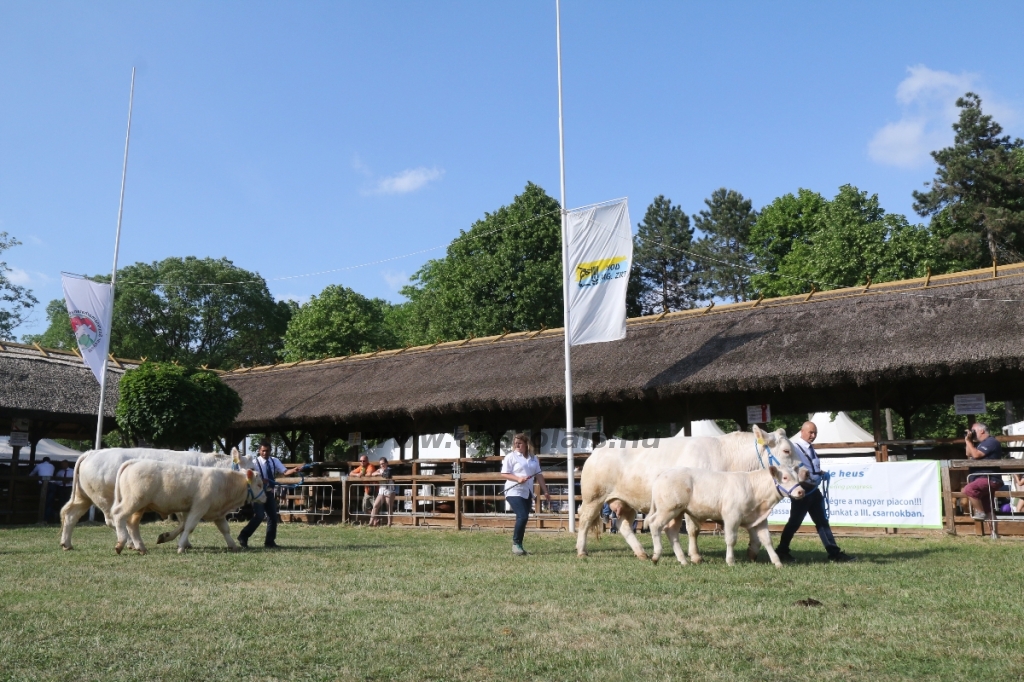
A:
<box><xmin>577</xmin><ymin>426</ymin><xmax>806</xmax><ymax>560</ymax></box>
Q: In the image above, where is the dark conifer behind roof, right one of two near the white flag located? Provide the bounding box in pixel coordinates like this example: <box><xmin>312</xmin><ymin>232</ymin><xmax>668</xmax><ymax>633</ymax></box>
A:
<box><xmin>693</xmin><ymin>187</ymin><xmax>758</xmax><ymax>303</ymax></box>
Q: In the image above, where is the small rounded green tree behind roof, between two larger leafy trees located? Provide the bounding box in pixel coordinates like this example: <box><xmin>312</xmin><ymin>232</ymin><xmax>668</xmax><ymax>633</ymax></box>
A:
<box><xmin>284</xmin><ymin>285</ymin><xmax>397</xmax><ymax>361</ymax></box>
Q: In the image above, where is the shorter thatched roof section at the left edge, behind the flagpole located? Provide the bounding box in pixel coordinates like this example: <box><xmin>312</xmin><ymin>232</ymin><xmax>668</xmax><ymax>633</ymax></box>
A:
<box><xmin>0</xmin><ymin>341</ymin><xmax>137</xmax><ymax>437</ymax></box>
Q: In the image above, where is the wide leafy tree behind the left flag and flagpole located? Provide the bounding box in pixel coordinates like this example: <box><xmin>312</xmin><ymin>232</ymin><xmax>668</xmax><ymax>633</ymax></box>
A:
<box><xmin>29</xmin><ymin>256</ymin><xmax>292</xmax><ymax>369</ymax></box>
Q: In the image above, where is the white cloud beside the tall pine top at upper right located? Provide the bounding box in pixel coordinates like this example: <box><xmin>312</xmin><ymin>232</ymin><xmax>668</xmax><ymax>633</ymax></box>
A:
<box><xmin>867</xmin><ymin>65</ymin><xmax>1015</xmax><ymax>168</ymax></box>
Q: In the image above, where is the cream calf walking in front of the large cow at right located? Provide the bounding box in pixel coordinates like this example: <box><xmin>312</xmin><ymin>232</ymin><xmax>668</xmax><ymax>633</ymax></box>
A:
<box><xmin>644</xmin><ymin>466</ymin><xmax>804</xmax><ymax>567</ymax></box>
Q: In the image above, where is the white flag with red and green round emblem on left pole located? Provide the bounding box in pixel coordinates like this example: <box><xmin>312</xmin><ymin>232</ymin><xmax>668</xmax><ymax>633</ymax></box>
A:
<box><xmin>60</xmin><ymin>272</ymin><xmax>114</xmax><ymax>381</ymax></box>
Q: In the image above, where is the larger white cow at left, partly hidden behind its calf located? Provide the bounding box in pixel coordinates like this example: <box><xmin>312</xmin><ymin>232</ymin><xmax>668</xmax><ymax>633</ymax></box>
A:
<box><xmin>60</xmin><ymin>447</ymin><xmax>253</xmax><ymax>550</ymax></box>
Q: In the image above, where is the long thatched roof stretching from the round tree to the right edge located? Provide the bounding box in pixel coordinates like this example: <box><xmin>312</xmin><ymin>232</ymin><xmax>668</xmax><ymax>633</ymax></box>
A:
<box><xmin>222</xmin><ymin>264</ymin><xmax>1024</xmax><ymax>433</ymax></box>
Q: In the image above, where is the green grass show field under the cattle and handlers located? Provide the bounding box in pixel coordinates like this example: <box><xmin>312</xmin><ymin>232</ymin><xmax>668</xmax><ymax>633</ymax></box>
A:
<box><xmin>0</xmin><ymin>524</ymin><xmax>1024</xmax><ymax>682</ymax></box>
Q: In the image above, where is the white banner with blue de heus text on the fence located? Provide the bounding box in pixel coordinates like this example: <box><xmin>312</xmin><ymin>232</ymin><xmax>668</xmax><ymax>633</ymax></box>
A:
<box><xmin>768</xmin><ymin>457</ymin><xmax>942</xmax><ymax>528</ymax></box>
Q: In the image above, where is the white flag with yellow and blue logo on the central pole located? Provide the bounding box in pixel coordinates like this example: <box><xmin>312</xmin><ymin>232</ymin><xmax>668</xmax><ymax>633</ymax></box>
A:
<box><xmin>565</xmin><ymin>199</ymin><xmax>633</xmax><ymax>346</ymax></box>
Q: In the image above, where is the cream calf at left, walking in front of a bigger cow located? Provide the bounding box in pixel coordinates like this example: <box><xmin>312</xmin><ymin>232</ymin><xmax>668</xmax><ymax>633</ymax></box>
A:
<box><xmin>111</xmin><ymin>460</ymin><xmax>264</xmax><ymax>554</ymax></box>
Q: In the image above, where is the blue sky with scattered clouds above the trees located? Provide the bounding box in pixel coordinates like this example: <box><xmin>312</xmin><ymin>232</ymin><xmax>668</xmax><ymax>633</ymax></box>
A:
<box><xmin>0</xmin><ymin>0</ymin><xmax>1024</xmax><ymax>334</ymax></box>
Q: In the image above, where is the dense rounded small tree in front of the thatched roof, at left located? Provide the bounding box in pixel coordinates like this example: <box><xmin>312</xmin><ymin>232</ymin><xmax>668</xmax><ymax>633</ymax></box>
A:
<box><xmin>116</xmin><ymin>363</ymin><xmax>242</xmax><ymax>449</ymax></box>
